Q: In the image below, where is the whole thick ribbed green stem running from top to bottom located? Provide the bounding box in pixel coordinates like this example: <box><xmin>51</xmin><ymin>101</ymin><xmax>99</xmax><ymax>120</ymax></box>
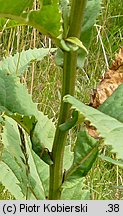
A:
<box><xmin>49</xmin><ymin>0</ymin><xmax>87</xmax><ymax>200</ymax></box>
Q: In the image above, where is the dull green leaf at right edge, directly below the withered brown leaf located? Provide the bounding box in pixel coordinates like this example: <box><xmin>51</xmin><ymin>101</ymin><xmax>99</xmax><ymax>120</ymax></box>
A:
<box><xmin>98</xmin><ymin>84</ymin><xmax>123</xmax><ymax>122</ymax></box>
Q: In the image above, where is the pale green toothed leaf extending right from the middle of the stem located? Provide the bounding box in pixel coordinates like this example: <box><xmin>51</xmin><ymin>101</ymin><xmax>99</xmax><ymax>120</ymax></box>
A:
<box><xmin>64</xmin><ymin>95</ymin><xmax>123</xmax><ymax>159</ymax></box>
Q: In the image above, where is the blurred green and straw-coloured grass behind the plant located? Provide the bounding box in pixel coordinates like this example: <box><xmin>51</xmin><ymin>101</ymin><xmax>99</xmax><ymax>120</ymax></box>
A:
<box><xmin>0</xmin><ymin>0</ymin><xmax>123</xmax><ymax>200</ymax></box>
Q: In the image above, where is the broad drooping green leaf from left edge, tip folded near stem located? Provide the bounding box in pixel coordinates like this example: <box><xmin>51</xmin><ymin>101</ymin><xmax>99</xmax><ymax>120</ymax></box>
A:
<box><xmin>0</xmin><ymin>71</ymin><xmax>55</xmax><ymax>163</ymax></box>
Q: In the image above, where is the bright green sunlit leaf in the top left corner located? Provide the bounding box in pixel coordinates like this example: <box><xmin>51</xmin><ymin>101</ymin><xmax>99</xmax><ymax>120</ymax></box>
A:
<box><xmin>0</xmin><ymin>0</ymin><xmax>61</xmax><ymax>38</ymax></box>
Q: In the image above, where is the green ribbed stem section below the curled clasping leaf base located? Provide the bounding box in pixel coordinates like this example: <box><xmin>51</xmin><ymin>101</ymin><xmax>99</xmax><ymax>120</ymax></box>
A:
<box><xmin>49</xmin><ymin>52</ymin><xmax>76</xmax><ymax>199</ymax></box>
